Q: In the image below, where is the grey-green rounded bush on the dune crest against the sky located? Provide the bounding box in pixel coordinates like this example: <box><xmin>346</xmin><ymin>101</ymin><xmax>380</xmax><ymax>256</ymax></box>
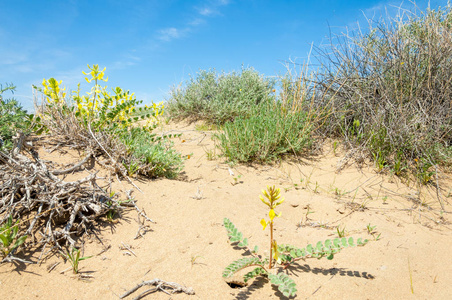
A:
<box><xmin>167</xmin><ymin>68</ymin><xmax>275</xmax><ymax>125</ymax></box>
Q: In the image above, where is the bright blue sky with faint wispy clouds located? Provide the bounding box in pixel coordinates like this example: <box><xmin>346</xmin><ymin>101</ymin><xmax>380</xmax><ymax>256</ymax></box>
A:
<box><xmin>0</xmin><ymin>0</ymin><xmax>447</xmax><ymax>109</ymax></box>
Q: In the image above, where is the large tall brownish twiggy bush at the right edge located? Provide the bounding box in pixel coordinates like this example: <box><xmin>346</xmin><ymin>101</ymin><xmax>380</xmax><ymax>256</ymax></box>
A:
<box><xmin>317</xmin><ymin>5</ymin><xmax>452</xmax><ymax>180</ymax></box>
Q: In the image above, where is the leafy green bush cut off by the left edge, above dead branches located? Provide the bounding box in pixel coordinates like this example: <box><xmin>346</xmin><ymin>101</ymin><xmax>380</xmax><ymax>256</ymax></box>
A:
<box><xmin>0</xmin><ymin>85</ymin><xmax>28</xmax><ymax>151</ymax></box>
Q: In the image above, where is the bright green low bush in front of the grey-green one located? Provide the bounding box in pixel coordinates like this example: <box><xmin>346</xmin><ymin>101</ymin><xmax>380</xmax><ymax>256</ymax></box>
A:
<box><xmin>215</xmin><ymin>103</ymin><xmax>312</xmax><ymax>162</ymax></box>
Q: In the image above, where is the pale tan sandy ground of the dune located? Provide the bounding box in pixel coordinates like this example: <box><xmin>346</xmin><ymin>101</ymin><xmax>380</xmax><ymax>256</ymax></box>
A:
<box><xmin>0</xmin><ymin>123</ymin><xmax>452</xmax><ymax>300</ymax></box>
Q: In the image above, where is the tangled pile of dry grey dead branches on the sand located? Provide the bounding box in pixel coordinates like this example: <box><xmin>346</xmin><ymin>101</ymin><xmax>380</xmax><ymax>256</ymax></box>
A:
<box><xmin>0</xmin><ymin>135</ymin><xmax>120</xmax><ymax>258</ymax></box>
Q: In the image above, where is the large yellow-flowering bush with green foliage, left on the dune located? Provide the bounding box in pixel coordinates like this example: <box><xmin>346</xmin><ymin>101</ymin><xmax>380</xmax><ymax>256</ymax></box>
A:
<box><xmin>32</xmin><ymin>65</ymin><xmax>183</xmax><ymax>178</ymax></box>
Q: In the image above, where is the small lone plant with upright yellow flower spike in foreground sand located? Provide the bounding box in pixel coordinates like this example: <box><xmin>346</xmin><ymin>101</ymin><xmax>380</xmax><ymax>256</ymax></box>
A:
<box><xmin>223</xmin><ymin>186</ymin><xmax>368</xmax><ymax>297</ymax></box>
